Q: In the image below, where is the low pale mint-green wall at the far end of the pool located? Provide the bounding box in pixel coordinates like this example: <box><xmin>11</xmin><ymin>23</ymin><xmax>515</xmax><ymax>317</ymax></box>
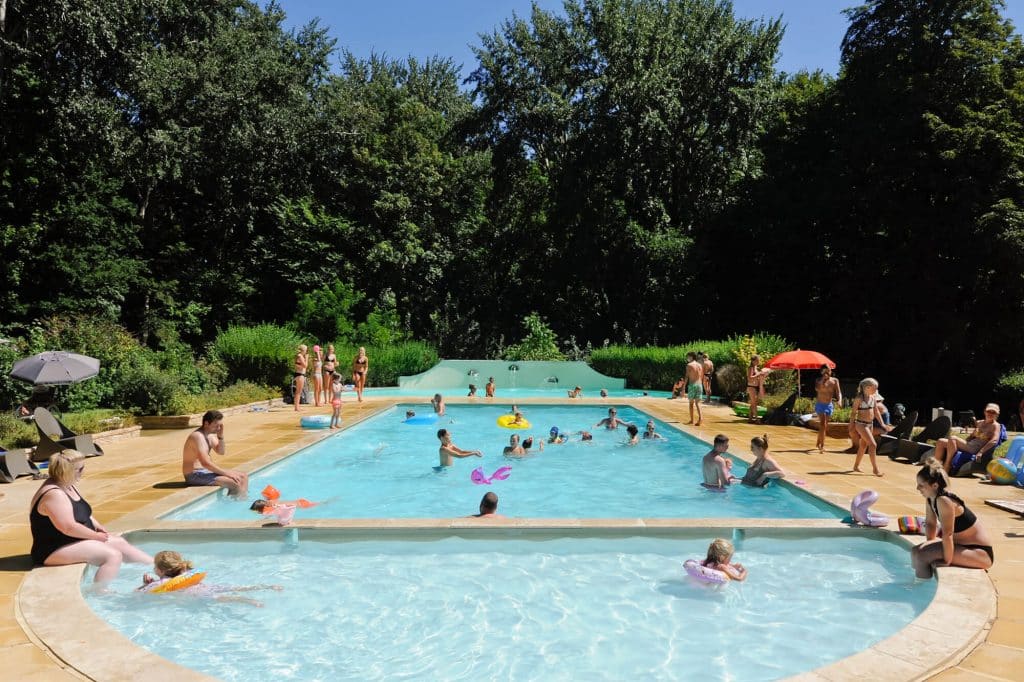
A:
<box><xmin>398</xmin><ymin>360</ymin><xmax>626</xmax><ymax>397</ymax></box>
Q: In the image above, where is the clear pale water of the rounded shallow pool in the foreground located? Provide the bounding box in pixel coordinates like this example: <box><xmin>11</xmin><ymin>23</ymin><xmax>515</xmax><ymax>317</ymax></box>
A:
<box><xmin>84</xmin><ymin>529</ymin><xmax>936</xmax><ymax>682</ymax></box>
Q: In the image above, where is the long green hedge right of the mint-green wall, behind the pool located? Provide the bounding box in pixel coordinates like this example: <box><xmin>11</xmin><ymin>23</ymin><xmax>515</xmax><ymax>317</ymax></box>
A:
<box><xmin>590</xmin><ymin>334</ymin><xmax>794</xmax><ymax>397</ymax></box>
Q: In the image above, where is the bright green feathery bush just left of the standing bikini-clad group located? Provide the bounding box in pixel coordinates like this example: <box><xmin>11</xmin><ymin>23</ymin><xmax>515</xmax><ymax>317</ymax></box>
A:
<box><xmin>213</xmin><ymin>325</ymin><xmax>302</xmax><ymax>386</ymax></box>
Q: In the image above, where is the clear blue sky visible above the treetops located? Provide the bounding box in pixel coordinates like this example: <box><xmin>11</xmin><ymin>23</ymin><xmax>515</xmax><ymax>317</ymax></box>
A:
<box><xmin>272</xmin><ymin>0</ymin><xmax>1024</xmax><ymax>76</ymax></box>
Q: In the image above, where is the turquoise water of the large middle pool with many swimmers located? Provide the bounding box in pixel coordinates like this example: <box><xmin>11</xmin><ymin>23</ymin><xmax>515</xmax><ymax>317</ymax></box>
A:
<box><xmin>168</xmin><ymin>404</ymin><xmax>846</xmax><ymax>521</ymax></box>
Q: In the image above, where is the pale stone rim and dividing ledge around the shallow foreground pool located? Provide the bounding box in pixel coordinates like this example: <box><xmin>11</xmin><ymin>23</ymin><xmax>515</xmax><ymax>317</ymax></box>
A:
<box><xmin>16</xmin><ymin>519</ymin><xmax>995</xmax><ymax>681</ymax></box>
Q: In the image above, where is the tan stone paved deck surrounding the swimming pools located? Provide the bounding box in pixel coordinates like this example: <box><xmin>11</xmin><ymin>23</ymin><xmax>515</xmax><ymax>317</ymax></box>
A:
<box><xmin>0</xmin><ymin>396</ymin><xmax>1024</xmax><ymax>682</ymax></box>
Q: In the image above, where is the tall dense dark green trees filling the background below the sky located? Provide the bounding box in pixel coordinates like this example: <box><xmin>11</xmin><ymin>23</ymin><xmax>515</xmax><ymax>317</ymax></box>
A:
<box><xmin>0</xmin><ymin>0</ymin><xmax>1024</xmax><ymax>409</ymax></box>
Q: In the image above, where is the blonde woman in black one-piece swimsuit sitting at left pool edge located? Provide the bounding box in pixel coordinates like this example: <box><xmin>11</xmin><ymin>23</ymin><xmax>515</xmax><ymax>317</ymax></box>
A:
<box><xmin>29</xmin><ymin>450</ymin><xmax>153</xmax><ymax>583</ymax></box>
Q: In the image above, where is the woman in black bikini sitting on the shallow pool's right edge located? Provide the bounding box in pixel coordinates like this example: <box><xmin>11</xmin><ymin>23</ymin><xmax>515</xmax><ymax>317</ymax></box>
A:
<box><xmin>910</xmin><ymin>458</ymin><xmax>995</xmax><ymax>578</ymax></box>
